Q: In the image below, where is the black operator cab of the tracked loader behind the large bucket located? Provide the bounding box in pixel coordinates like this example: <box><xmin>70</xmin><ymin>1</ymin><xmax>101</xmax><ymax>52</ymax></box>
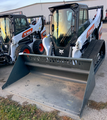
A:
<box><xmin>49</xmin><ymin>3</ymin><xmax>90</xmax><ymax>57</ymax></box>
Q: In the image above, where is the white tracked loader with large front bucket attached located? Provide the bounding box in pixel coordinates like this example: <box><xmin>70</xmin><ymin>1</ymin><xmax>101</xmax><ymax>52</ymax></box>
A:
<box><xmin>2</xmin><ymin>3</ymin><xmax>105</xmax><ymax>116</ymax></box>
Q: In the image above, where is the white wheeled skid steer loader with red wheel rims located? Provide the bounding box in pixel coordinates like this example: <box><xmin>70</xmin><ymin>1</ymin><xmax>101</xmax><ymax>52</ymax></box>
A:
<box><xmin>0</xmin><ymin>13</ymin><xmax>46</xmax><ymax>65</ymax></box>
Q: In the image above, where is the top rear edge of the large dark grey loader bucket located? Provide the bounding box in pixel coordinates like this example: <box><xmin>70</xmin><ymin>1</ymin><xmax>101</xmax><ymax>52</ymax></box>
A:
<box><xmin>19</xmin><ymin>53</ymin><xmax>93</xmax><ymax>62</ymax></box>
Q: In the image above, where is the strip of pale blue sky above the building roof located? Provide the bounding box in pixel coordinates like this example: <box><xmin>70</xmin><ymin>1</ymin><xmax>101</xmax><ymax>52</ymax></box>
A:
<box><xmin>0</xmin><ymin>0</ymin><xmax>79</xmax><ymax>12</ymax></box>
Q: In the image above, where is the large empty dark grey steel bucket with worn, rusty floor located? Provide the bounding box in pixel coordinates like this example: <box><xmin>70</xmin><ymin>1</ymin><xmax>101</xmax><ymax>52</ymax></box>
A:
<box><xmin>2</xmin><ymin>53</ymin><xmax>95</xmax><ymax>116</ymax></box>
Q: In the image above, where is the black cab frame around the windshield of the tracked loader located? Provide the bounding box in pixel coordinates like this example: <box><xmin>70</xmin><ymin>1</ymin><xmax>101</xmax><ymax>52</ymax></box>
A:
<box><xmin>49</xmin><ymin>3</ymin><xmax>89</xmax><ymax>57</ymax></box>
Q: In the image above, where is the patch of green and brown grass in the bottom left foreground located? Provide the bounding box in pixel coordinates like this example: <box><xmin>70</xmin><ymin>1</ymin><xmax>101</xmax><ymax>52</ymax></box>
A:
<box><xmin>0</xmin><ymin>96</ymin><xmax>73</xmax><ymax>120</ymax></box>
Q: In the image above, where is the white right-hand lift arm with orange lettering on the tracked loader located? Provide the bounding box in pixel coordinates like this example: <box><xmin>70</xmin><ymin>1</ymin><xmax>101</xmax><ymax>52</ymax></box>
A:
<box><xmin>72</xmin><ymin>7</ymin><xmax>102</xmax><ymax>58</ymax></box>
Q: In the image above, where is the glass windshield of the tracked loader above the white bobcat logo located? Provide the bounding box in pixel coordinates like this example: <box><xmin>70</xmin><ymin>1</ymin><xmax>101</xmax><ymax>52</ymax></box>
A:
<box><xmin>52</xmin><ymin>8</ymin><xmax>74</xmax><ymax>47</ymax></box>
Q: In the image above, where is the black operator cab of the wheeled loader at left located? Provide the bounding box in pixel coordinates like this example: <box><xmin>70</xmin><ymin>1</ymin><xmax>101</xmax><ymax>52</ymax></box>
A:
<box><xmin>0</xmin><ymin>14</ymin><xmax>30</xmax><ymax>53</ymax></box>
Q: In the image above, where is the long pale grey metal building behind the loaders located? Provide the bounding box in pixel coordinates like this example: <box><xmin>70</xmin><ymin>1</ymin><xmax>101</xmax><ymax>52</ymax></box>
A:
<box><xmin>0</xmin><ymin>0</ymin><xmax>107</xmax><ymax>21</ymax></box>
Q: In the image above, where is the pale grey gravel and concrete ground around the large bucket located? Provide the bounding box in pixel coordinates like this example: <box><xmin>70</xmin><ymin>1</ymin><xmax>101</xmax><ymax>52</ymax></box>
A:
<box><xmin>0</xmin><ymin>24</ymin><xmax>107</xmax><ymax>120</ymax></box>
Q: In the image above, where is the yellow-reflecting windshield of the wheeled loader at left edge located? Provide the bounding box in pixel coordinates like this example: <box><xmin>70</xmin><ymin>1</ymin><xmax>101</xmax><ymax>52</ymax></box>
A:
<box><xmin>0</xmin><ymin>17</ymin><xmax>10</xmax><ymax>43</ymax></box>
